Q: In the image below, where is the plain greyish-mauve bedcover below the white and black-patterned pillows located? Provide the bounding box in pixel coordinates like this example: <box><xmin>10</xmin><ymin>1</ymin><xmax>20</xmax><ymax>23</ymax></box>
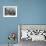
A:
<box><xmin>20</xmin><ymin>40</ymin><xmax>46</xmax><ymax>46</ymax></box>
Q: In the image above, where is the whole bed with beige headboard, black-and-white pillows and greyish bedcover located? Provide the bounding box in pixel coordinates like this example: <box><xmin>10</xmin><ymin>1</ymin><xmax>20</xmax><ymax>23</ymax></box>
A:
<box><xmin>18</xmin><ymin>24</ymin><xmax>46</xmax><ymax>46</ymax></box>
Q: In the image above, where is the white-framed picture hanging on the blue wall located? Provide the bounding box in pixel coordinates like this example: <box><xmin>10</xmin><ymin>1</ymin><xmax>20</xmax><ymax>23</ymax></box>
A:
<box><xmin>3</xmin><ymin>6</ymin><xmax>17</xmax><ymax>17</ymax></box>
